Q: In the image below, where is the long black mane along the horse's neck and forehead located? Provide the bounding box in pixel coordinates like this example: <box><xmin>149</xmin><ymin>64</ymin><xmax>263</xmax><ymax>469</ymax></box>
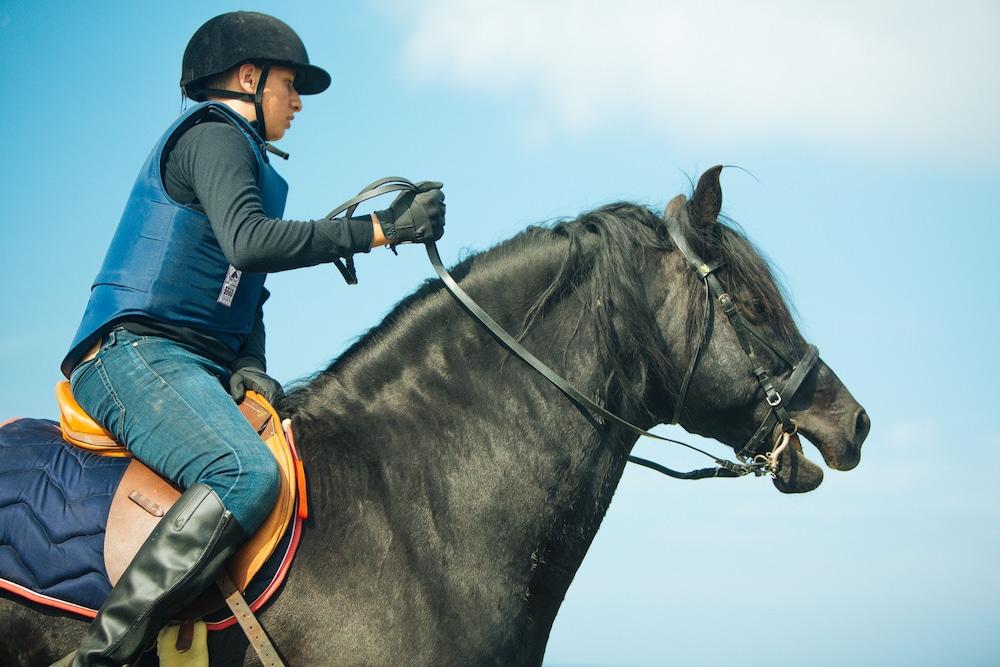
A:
<box><xmin>282</xmin><ymin>202</ymin><xmax>801</xmax><ymax>420</ymax></box>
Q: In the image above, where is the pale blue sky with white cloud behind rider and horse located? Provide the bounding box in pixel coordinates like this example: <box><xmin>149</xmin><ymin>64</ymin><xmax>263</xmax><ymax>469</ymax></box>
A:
<box><xmin>0</xmin><ymin>0</ymin><xmax>1000</xmax><ymax>667</ymax></box>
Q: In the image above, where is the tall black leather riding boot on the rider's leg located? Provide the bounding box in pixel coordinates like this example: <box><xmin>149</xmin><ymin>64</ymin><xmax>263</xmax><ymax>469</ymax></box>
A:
<box><xmin>67</xmin><ymin>484</ymin><xmax>247</xmax><ymax>667</ymax></box>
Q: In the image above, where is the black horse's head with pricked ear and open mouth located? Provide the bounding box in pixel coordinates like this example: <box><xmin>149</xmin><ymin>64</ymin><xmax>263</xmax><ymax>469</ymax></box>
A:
<box><xmin>657</xmin><ymin>167</ymin><xmax>869</xmax><ymax>493</ymax></box>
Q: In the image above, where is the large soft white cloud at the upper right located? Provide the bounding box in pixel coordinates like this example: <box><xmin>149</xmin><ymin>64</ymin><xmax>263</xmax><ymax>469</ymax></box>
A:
<box><xmin>380</xmin><ymin>0</ymin><xmax>1000</xmax><ymax>163</ymax></box>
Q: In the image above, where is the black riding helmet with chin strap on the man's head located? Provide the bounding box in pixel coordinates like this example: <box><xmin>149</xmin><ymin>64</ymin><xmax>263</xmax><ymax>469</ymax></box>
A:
<box><xmin>181</xmin><ymin>12</ymin><xmax>330</xmax><ymax>141</ymax></box>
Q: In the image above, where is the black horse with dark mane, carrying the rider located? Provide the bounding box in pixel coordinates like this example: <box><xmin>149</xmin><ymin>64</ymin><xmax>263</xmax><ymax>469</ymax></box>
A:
<box><xmin>0</xmin><ymin>169</ymin><xmax>869</xmax><ymax>665</ymax></box>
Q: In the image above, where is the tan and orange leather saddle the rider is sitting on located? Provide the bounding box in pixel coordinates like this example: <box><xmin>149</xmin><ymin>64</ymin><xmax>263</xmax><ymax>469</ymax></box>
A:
<box><xmin>56</xmin><ymin>380</ymin><xmax>307</xmax><ymax>606</ymax></box>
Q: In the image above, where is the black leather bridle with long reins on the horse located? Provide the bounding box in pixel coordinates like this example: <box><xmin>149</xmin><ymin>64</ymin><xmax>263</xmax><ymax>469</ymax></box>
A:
<box><xmin>327</xmin><ymin>176</ymin><xmax>819</xmax><ymax>479</ymax></box>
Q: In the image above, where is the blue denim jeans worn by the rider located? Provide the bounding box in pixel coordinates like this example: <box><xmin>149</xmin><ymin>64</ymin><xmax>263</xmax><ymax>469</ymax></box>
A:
<box><xmin>70</xmin><ymin>328</ymin><xmax>280</xmax><ymax>535</ymax></box>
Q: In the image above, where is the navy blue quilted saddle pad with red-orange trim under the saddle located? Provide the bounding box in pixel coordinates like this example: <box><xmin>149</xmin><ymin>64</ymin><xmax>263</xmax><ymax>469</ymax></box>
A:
<box><xmin>0</xmin><ymin>419</ymin><xmax>298</xmax><ymax>620</ymax></box>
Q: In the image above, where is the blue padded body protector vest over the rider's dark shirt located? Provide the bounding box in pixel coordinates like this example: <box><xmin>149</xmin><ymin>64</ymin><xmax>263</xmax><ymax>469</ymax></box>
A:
<box><xmin>62</xmin><ymin>102</ymin><xmax>288</xmax><ymax>377</ymax></box>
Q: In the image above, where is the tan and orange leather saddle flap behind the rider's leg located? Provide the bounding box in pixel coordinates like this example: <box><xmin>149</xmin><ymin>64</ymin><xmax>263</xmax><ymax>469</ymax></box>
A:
<box><xmin>104</xmin><ymin>391</ymin><xmax>298</xmax><ymax>604</ymax></box>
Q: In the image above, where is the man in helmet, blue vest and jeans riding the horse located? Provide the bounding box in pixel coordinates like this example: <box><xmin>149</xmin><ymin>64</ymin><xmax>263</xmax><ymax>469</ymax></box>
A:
<box><xmin>62</xmin><ymin>12</ymin><xmax>444</xmax><ymax>665</ymax></box>
